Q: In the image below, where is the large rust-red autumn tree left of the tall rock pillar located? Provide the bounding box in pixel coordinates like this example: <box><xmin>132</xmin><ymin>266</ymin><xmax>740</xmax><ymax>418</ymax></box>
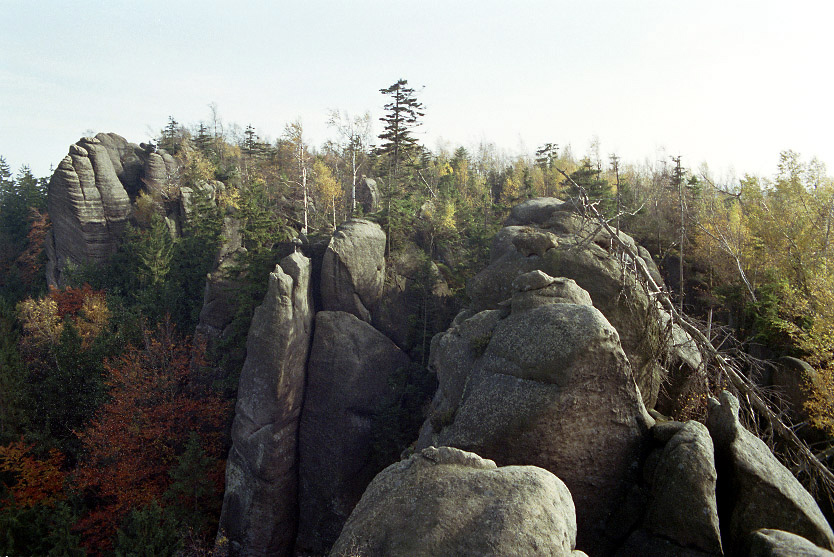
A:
<box><xmin>75</xmin><ymin>323</ymin><xmax>228</xmax><ymax>549</ymax></box>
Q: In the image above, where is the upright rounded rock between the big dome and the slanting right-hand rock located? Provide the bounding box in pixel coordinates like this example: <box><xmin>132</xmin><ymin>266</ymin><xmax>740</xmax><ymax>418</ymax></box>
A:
<box><xmin>645</xmin><ymin>421</ymin><xmax>722</xmax><ymax>554</ymax></box>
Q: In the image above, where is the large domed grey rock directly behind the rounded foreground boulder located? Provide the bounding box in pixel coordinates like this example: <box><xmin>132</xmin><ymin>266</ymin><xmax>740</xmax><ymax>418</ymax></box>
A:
<box><xmin>417</xmin><ymin>277</ymin><xmax>653</xmax><ymax>554</ymax></box>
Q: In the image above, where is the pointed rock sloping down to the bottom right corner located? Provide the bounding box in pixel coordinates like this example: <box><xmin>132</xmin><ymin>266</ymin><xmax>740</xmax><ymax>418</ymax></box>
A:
<box><xmin>707</xmin><ymin>391</ymin><xmax>834</xmax><ymax>551</ymax></box>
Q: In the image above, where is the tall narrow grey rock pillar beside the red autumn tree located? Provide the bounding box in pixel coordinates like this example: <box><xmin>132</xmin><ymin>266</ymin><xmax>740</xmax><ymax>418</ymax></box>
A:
<box><xmin>218</xmin><ymin>253</ymin><xmax>313</xmax><ymax>555</ymax></box>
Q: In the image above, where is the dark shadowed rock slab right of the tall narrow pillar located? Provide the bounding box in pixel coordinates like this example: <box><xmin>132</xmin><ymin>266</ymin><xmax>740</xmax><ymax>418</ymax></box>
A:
<box><xmin>296</xmin><ymin>311</ymin><xmax>410</xmax><ymax>554</ymax></box>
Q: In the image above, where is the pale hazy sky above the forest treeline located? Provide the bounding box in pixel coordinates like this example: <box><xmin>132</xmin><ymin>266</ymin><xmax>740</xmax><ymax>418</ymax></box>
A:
<box><xmin>0</xmin><ymin>0</ymin><xmax>834</xmax><ymax>178</ymax></box>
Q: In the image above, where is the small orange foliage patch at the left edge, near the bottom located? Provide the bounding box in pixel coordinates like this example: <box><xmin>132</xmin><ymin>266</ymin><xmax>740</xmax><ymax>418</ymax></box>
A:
<box><xmin>0</xmin><ymin>439</ymin><xmax>66</xmax><ymax>508</ymax></box>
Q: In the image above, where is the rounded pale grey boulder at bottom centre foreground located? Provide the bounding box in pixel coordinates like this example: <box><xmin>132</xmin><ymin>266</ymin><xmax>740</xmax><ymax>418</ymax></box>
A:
<box><xmin>330</xmin><ymin>447</ymin><xmax>576</xmax><ymax>557</ymax></box>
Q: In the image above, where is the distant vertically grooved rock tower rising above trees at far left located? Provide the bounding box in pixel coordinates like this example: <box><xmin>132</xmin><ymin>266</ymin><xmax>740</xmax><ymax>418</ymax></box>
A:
<box><xmin>47</xmin><ymin>137</ymin><xmax>131</xmax><ymax>285</ymax></box>
